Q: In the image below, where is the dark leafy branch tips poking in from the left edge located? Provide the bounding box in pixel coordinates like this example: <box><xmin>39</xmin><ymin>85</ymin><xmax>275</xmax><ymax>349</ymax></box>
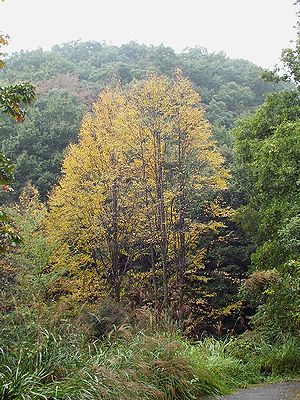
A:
<box><xmin>0</xmin><ymin>35</ymin><xmax>34</xmax><ymax>253</ymax></box>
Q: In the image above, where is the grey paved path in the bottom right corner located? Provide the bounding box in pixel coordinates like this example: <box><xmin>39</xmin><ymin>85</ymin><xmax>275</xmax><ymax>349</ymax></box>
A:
<box><xmin>206</xmin><ymin>382</ymin><xmax>300</xmax><ymax>400</ymax></box>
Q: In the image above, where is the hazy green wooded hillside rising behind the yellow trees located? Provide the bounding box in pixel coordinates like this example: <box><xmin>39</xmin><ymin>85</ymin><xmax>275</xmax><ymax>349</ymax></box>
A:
<box><xmin>0</xmin><ymin>42</ymin><xmax>282</xmax><ymax>200</ymax></box>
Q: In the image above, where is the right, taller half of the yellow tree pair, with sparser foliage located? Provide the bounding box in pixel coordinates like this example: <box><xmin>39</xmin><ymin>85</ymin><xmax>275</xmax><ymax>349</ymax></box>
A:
<box><xmin>128</xmin><ymin>71</ymin><xmax>228</xmax><ymax>313</ymax></box>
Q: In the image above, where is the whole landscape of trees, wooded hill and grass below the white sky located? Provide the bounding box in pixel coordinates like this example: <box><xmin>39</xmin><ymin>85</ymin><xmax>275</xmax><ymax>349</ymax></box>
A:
<box><xmin>0</xmin><ymin>7</ymin><xmax>300</xmax><ymax>400</ymax></box>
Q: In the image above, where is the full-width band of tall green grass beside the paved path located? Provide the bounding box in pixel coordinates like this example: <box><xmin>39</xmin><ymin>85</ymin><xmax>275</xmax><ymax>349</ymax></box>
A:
<box><xmin>0</xmin><ymin>318</ymin><xmax>300</xmax><ymax>400</ymax></box>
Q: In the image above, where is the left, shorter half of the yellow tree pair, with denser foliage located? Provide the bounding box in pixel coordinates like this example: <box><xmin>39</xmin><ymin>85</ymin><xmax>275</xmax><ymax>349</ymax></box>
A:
<box><xmin>48</xmin><ymin>87</ymin><xmax>143</xmax><ymax>300</ymax></box>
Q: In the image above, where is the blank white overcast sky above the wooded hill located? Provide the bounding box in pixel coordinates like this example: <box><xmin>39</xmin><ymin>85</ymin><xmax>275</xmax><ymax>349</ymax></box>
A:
<box><xmin>0</xmin><ymin>0</ymin><xmax>296</xmax><ymax>67</ymax></box>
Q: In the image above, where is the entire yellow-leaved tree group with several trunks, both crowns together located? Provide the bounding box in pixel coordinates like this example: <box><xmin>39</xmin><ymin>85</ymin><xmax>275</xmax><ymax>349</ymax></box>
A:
<box><xmin>49</xmin><ymin>71</ymin><xmax>228</xmax><ymax>312</ymax></box>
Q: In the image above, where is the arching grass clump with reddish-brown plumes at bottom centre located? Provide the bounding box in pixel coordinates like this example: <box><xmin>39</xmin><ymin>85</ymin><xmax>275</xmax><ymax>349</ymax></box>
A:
<box><xmin>98</xmin><ymin>334</ymin><xmax>228</xmax><ymax>400</ymax></box>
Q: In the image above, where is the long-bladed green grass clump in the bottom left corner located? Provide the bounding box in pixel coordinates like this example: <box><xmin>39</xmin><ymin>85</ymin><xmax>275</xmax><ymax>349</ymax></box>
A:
<box><xmin>0</xmin><ymin>326</ymin><xmax>83</xmax><ymax>400</ymax></box>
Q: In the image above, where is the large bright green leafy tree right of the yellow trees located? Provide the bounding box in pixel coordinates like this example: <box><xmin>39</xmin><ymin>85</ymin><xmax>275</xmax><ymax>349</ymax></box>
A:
<box><xmin>235</xmin><ymin>92</ymin><xmax>300</xmax><ymax>268</ymax></box>
